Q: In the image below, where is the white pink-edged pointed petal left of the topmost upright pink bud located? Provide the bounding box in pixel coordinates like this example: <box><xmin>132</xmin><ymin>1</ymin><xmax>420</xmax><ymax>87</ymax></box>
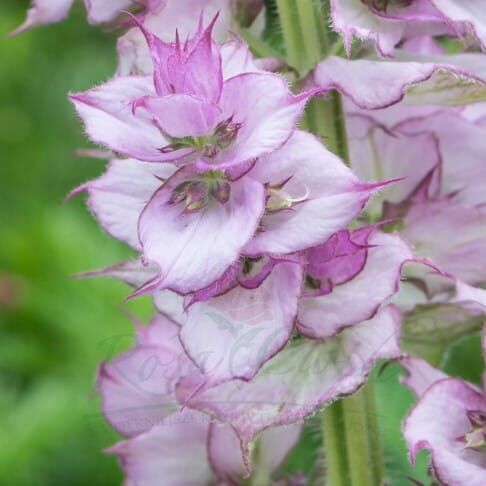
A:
<box><xmin>70</xmin><ymin>76</ymin><xmax>191</xmax><ymax>162</ymax></box>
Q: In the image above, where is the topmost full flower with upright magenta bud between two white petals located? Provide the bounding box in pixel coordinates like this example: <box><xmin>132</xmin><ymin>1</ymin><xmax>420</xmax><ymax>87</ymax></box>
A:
<box><xmin>71</xmin><ymin>19</ymin><xmax>313</xmax><ymax>170</ymax></box>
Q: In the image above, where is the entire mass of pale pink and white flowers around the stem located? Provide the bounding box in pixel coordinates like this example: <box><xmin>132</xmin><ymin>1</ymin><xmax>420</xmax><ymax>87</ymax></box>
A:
<box><xmin>21</xmin><ymin>0</ymin><xmax>486</xmax><ymax>485</ymax></box>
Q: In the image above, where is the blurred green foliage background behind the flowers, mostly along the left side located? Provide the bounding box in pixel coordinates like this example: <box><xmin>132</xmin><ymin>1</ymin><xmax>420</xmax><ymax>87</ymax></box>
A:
<box><xmin>0</xmin><ymin>0</ymin><xmax>481</xmax><ymax>486</ymax></box>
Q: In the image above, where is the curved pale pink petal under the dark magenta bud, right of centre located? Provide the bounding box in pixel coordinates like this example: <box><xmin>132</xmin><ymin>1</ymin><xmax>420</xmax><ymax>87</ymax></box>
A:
<box><xmin>297</xmin><ymin>231</ymin><xmax>412</xmax><ymax>339</ymax></box>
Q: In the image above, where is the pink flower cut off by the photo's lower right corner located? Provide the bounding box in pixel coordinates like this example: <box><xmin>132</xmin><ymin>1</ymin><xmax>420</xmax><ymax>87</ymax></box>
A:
<box><xmin>401</xmin><ymin>330</ymin><xmax>486</xmax><ymax>486</ymax></box>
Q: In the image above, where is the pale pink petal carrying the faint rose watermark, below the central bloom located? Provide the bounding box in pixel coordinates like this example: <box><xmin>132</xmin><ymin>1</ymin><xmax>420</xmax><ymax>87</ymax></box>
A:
<box><xmin>180</xmin><ymin>263</ymin><xmax>302</xmax><ymax>385</ymax></box>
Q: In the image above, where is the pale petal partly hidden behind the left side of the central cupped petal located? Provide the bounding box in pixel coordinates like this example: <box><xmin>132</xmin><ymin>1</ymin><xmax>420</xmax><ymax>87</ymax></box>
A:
<box><xmin>82</xmin><ymin>159</ymin><xmax>175</xmax><ymax>249</ymax></box>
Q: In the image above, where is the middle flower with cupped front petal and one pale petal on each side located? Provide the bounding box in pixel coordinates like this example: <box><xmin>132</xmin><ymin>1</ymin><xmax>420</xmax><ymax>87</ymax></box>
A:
<box><xmin>72</xmin><ymin>125</ymin><xmax>381</xmax><ymax>300</ymax></box>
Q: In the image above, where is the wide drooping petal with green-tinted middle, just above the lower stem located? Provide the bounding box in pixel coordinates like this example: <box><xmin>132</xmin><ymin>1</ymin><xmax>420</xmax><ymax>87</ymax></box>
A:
<box><xmin>178</xmin><ymin>307</ymin><xmax>400</xmax><ymax>450</ymax></box>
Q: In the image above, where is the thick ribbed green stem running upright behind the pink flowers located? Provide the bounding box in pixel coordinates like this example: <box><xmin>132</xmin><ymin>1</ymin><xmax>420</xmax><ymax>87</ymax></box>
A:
<box><xmin>276</xmin><ymin>0</ymin><xmax>383</xmax><ymax>486</ymax></box>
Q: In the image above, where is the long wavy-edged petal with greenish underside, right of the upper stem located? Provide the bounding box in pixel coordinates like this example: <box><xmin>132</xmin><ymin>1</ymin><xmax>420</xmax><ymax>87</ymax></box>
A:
<box><xmin>314</xmin><ymin>52</ymin><xmax>486</xmax><ymax>109</ymax></box>
